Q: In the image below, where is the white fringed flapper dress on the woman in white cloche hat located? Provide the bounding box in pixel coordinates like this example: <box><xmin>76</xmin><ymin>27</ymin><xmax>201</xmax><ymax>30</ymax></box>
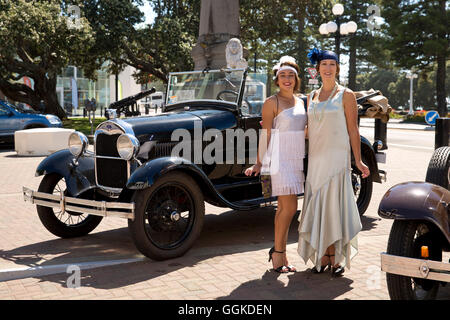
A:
<box><xmin>261</xmin><ymin>98</ymin><xmax>307</xmax><ymax>196</ymax></box>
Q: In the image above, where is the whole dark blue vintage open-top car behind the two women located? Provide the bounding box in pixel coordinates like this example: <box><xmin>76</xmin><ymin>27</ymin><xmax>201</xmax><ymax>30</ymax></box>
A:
<box><xmin>23</xmin><ymin>69</ymin><xmax>384</xmax><ymax>260</ymax></box>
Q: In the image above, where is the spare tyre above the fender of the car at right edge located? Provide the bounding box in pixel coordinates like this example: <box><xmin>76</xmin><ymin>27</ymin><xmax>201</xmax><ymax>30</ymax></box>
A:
<box><xmin>425</xmin><ymin>147</ymin><xmax>450</xmax><ymax>189</ymax></box>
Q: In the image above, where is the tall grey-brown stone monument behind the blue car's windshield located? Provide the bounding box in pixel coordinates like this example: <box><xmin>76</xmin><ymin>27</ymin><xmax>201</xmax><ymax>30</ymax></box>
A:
<box><xmin>191</xmin><ymin>0</ymin><xmax>247</xmax><ymax>70</ymax></box>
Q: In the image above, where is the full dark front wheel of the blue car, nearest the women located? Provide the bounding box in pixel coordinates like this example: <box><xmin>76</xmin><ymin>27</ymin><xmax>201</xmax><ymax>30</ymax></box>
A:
<box><xmin>128</xmin><ymin>172</ymin><xmax>205</xmax><ymax>260</ymax></box>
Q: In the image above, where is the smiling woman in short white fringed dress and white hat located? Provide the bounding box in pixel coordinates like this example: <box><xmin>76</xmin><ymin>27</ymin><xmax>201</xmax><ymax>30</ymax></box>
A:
<box><xmin>245</xmin><ymin>56</ymin><xmax>307</xmax><ymax>273</ymax></box>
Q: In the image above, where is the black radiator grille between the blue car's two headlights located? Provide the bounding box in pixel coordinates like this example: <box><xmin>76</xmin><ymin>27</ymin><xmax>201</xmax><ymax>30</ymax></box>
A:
<box><xmin>95</xmin><ymin>133</ymin><xmax>128</xmax><ymax>188</ymax></box>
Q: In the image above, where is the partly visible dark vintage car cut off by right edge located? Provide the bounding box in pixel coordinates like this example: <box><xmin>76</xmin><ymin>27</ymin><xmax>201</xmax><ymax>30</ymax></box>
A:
<box><xmin>378</xmin><ymin>147</ymin><xmax>450</xmax><ymax>300</ymax></box>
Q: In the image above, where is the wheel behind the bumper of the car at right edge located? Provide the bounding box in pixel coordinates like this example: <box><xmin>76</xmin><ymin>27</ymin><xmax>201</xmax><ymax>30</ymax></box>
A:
<box><xmin>386</xmin><ymin>220</ymin><xmax>442</xmax><ymax>300</ymax></box>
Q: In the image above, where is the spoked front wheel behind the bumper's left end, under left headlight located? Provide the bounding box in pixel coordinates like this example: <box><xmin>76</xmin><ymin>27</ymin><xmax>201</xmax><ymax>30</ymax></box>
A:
<box><xmin>36</xmin><ymin>173</ymin><xmax>103</xmax><ymax>238</ymax></box>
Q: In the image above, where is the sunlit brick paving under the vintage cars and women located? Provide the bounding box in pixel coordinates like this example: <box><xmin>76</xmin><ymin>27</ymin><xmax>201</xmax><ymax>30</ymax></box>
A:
<box><xmin>0</xmin><ymin>139</ymin><xmax>450</xmax><ymax>300</ymax></box>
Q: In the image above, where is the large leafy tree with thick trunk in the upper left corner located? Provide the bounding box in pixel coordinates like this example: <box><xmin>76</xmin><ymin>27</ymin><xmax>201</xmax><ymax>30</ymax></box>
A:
<box><xmin>0</xmin><ymin>0</ymin><xmax>96</xmax><ymax>118</ymax></box>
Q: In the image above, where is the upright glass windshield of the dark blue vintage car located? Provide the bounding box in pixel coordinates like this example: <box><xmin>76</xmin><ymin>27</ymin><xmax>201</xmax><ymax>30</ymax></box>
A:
<box><xmin>166</xmin><ymin>69</ymin><xmax>245</xmax><ymax>105</ymax></box>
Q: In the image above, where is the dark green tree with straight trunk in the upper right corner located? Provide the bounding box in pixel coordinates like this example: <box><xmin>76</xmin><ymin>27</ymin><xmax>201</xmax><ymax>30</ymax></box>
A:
<box><xmin>383</xmin><ymin>0</ymin><xmax>450</xmax><ymax>117</ymax></box>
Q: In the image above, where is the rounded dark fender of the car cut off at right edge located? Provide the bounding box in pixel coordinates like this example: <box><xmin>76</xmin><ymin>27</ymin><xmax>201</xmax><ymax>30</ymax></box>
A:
<box><xmin>378</xmin><ymin>182</ymin><xmax>450</xmax><ymax>244</ymax></box>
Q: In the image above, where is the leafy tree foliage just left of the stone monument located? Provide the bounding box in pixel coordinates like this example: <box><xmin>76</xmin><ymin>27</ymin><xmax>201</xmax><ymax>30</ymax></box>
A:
<box><xmin>96</xmin><ymin>0</ymin><xmax>200</xmax><ymax>82</ymax></box>
